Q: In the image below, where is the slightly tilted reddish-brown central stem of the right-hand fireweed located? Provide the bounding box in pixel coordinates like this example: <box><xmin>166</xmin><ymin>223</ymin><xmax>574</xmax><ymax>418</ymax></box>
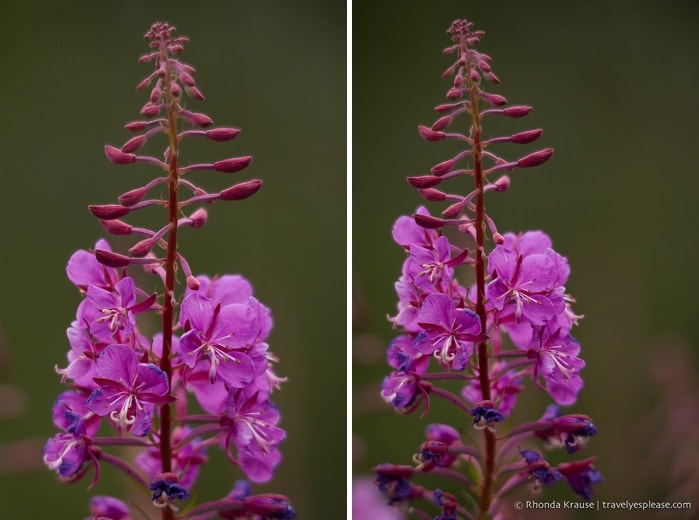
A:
<box><xmin>464</xmin><ymin>52</ymin><xmax>495</xmax><ymax>518</ymax></box>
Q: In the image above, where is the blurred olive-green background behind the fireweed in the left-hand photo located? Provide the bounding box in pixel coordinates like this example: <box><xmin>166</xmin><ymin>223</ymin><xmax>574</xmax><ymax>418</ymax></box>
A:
<box><xmin>0</xmin><ymin>0</ymin><xmax>347</xmax><ymax>520</ymax></box>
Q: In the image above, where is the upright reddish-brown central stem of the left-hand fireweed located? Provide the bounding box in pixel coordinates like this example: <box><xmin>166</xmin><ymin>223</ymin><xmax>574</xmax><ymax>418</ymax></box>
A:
<box><xmin>160</xmin><ymin>53</ymin><xmax>179</xmax><ymax>520</ymax></box>
